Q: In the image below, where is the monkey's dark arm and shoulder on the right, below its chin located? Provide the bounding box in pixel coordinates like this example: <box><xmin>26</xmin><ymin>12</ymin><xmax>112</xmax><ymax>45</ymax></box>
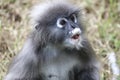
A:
<box><xmin>75</xmin><ymin>40</ymin><xmax>100</xmax><ymax>80</ymax></box>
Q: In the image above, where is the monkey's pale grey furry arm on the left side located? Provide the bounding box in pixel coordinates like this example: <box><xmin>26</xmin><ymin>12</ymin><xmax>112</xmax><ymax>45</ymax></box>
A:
<box><xmin>4</xmin><ymin>40</ymin><xmax>42</xmax><ymax>80</ymax></box>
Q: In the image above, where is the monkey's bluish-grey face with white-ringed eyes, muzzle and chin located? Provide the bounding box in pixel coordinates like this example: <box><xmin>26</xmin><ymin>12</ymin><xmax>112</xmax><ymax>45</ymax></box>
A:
<box><xmin>55</xmin><ymin>13</ymin><xmax>82</xmax><ymax>49</ymax></box>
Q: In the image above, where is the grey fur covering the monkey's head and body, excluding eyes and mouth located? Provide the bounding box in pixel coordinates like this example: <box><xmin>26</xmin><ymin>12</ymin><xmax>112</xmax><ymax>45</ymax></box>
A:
<box><xmin>4</xmin><ymin>0</ymin><xmax>100</xmax><ymax>80</ymax></box>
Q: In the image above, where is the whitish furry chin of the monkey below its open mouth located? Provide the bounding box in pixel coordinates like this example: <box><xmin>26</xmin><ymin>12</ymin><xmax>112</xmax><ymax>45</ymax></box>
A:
<box><xmin>64</xmin><ymin>37</ymin><xmax>83</xmax><ymax>50</ymax></box>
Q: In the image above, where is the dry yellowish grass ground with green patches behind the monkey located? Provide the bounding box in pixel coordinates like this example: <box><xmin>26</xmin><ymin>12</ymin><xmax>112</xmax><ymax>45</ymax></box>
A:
<box><xmin>0</xmin><ymin>0</ymin><xmax>120</xmax><ymax>80</ymax></box>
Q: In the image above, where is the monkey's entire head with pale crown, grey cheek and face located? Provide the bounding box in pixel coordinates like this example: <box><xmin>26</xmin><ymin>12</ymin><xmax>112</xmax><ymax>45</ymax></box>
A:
<box><xmin>30</xmin><ymin>2</ymin><xmax>84</xmax><ymax>49</ymax></box>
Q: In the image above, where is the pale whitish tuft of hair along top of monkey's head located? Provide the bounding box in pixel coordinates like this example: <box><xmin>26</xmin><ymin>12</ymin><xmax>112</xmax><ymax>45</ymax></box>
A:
<box><xmin>29</xmin><ymin>0</ymin><xmax>78</xmax><ymax>27</ymax></box>
